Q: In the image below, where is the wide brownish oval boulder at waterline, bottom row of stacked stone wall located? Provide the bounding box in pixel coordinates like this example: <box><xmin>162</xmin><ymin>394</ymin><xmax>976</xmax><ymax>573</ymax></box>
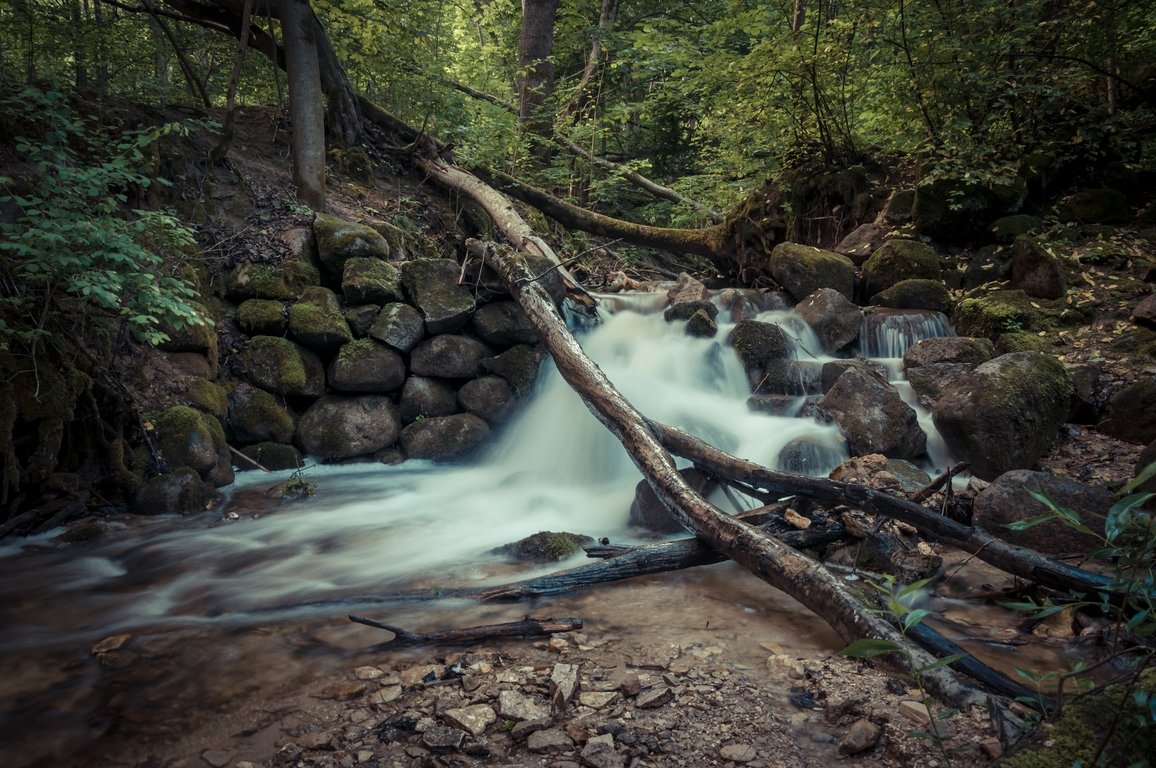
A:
<box><xmin>295</xmin><ymin>394</ymin><xmax>401</xmax><ymax>460</ymax></box>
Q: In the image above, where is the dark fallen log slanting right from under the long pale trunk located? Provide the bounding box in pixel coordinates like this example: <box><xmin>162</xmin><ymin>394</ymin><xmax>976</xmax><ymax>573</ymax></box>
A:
<box><xmin>649</xmin><ymin>421</ymin><xmax>1112</xmax><ymax>595</ymax></box>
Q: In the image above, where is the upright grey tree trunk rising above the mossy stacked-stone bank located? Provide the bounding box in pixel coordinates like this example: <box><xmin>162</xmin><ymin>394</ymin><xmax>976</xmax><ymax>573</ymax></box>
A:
<box><xmin>277</xmin><ymin>0</ymin><xmax>325</xmax><ymax>211</ymax></box>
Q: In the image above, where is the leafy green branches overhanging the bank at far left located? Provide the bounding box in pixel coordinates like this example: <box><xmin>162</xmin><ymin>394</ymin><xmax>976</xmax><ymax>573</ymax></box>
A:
<box><xmin>0</xmin><ymin>88</ymin><xmax>207</xmax><ymax>346</ymax></box>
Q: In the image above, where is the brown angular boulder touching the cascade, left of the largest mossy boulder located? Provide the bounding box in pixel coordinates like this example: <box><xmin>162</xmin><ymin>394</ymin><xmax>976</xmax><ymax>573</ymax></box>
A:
<box><xmin>817</xmin><ymin>368</ymin><xmax>927</xmax><ymax>459</ymax></box>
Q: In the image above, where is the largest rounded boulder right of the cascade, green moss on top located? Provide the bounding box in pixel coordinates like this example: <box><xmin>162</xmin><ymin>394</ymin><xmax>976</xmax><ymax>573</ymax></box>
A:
<box><xmin>932</xmin><ymin>352</ymin><xmax>1073</xmax><ymax>480</ymax></box>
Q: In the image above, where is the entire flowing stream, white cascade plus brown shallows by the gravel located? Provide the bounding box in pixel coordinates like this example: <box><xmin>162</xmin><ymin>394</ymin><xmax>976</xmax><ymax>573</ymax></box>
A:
<box><xmin>0</xmin><ymin>296</ymin><xmax>1058</xmax><ymax>766</ymax></box>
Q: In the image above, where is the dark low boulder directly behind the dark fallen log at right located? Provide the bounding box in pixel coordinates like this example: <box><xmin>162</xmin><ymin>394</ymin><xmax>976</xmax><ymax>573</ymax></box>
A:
<box><xmin>971</xmin><ymin>470</ymin><xmax>1114</xmax><ymax>554</ymax></box>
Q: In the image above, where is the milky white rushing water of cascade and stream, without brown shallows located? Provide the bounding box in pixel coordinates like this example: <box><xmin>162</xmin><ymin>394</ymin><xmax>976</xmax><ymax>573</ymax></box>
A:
<box><xmin>0</xmin><ymin>295</ymin><xmax>957</xmax><ymax>652</ymax></box>
